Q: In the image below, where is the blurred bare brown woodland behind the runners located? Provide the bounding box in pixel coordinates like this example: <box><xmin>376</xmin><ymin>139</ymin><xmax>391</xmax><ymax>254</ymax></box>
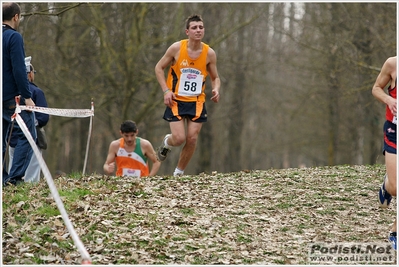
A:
<box><xmin>19</xmin><ymin>2</ymin><xmax>397</xmax><ymax>178</ymax></box>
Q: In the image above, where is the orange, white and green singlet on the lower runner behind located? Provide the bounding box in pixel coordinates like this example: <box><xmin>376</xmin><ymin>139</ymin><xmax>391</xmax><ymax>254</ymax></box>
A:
<box><xmin>115</xmin><ymin>137</ymin><xmax>150</xmax><ymax>177</ymax></box>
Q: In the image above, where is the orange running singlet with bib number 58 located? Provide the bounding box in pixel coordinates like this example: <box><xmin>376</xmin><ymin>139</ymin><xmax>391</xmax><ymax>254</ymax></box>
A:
<box><xmin>166</xmin><ymin>39</ymin><xmax>209</xmax><ymax>102</ymax></box>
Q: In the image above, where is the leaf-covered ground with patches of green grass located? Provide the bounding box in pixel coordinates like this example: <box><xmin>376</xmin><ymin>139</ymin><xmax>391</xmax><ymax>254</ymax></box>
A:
<box><xmin>2</xmin><ymin>165</ymin><xmax>396</xmax><ymax>265</ymax></box>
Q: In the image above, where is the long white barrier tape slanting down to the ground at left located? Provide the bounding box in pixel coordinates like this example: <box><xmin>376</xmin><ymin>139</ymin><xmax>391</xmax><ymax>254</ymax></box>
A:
<box><xmin>14</xmin><ymin>113</ymin><xmax>91</xmax><ymax>264</ymax></box>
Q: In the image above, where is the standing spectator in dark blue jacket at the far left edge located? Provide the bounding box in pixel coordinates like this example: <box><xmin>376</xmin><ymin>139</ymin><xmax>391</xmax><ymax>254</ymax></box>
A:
<box><xmin>2</xmin><ymin>2</ymin><xmax>36</xmax><ymax>186</ymax></box>
